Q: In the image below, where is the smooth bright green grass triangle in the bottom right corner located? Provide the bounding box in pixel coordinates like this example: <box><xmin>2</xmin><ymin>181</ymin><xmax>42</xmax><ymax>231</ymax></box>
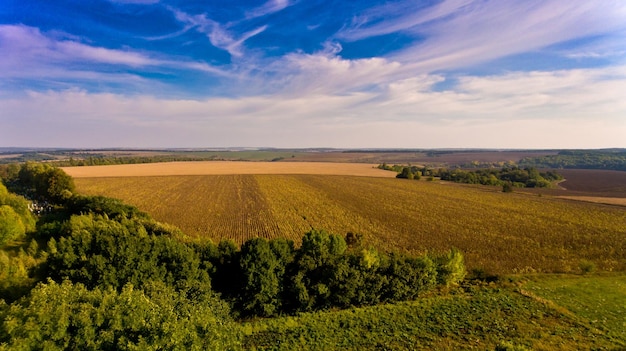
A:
<box><xmin>525</xmin><ymin>275</ymin><xmax>626</xmax><ymax>347</ymax></box>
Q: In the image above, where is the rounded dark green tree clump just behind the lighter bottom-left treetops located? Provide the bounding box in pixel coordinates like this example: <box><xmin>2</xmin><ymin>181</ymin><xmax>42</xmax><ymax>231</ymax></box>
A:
<box><xmin>48</xmin><ymin>214</ymin><xmax>211</xmax><ymax>290</ymax></box>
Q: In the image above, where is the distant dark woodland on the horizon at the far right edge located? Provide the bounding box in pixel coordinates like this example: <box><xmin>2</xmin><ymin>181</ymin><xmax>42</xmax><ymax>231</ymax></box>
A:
<box><xmin>519</xmin><ymin>149</ymin><xmax>626</xmax><ymax>171</ymax></box>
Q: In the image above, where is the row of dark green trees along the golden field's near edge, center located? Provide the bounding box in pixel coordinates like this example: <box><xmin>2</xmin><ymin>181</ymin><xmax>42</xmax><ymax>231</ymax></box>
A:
<box><xmin>213</xmin><ymin>230</ymin><xmax>465</xmax><ymax>316</ymax></box>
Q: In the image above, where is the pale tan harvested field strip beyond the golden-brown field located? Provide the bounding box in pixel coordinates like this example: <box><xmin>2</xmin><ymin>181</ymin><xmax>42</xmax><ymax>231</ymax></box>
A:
<box><xmin>63</xmin><ymin>161</ymin><xmax>396</xmax><ymax>178</ymax></box>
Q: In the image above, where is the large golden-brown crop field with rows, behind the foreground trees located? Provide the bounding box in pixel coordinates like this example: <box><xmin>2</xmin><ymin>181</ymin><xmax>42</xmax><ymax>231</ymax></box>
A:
<box><xmin>76</xmin><ymin>176</ymin><xmax>626</xmax><ymax>272</ymax></box>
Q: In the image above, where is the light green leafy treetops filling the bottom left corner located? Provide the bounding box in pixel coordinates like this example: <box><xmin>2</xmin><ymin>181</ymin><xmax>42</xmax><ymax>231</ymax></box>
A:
<box><xmin>0</xmin><ymin>281</ymin><xmax>240</xmax><ymax>350</ymax></box>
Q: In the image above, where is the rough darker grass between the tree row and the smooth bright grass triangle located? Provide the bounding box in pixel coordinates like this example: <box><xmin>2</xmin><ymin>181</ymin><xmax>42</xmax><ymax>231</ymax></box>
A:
<box><xmin>243</xmin><ymin>286</ymin><xmax>624</xmax><ymax>350</ymax></box>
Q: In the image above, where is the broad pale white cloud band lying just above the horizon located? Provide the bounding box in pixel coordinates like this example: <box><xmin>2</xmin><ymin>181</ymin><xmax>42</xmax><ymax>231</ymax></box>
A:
<box><xmin>0</xmin><ymin>65</ymin><xmax>626</xmax><ymax>148</ymax></box>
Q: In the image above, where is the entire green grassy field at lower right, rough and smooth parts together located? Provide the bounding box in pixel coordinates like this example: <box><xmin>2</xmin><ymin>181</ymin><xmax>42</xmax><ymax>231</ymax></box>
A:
<box><xmin>244</xmin><ymin>275</ymin><xmax>626</xmax><ymax>350</ymax></box>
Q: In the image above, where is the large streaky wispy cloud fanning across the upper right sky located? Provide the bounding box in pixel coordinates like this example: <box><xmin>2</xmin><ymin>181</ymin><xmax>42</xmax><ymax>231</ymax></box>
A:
<box><xmin>337</xmin><ymin>0</ymin><xmax>626</xmax><ymax>72</ymax></box>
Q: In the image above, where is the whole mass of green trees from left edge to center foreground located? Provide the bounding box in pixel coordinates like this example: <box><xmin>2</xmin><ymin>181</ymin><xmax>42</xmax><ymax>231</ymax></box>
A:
<box><xmin>0</xmin><ymin>163</ymin><xmax>465</xmax><ymax>350</ymax></box>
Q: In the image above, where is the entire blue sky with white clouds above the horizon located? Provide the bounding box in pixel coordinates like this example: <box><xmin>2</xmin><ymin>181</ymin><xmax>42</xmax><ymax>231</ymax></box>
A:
<box><xmin>0</xmin><ymin>0</ymin><xmax>626</xmax><ymax>149</ymax></box>
